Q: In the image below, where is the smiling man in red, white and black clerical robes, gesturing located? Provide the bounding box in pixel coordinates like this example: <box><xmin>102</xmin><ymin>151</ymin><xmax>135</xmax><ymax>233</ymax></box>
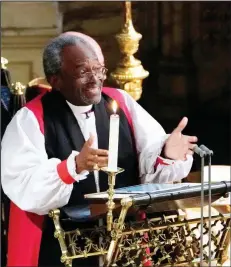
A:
<box><xmin>2</xmin><ymin>32</ymin><xmax>197</xmax><ymax>266</ymax></box>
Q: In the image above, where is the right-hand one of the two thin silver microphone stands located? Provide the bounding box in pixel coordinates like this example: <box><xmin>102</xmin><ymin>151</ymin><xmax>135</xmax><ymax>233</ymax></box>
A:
<box><xmin>200</xmin><ymin>145</ymin><xmax>213</xmax><ymax>267</ymax></box>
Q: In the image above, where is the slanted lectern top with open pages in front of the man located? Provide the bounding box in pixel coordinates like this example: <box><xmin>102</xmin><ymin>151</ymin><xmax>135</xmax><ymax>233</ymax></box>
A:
<box><xmin>85</xmin><ymin>181</ymin><xmax>231</xmax><ymax>210</ymax></box>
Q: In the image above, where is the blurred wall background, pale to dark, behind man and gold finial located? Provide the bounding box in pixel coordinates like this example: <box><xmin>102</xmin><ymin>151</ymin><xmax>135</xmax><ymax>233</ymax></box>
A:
<box><xmin>1</xmin><ymin>1</ymin><xmax>231</xmax><ymax>170</ymax></box>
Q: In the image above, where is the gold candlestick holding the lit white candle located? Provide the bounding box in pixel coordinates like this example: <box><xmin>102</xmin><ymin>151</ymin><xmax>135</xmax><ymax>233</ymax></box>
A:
<box><xmin>101</xmin><ymin>167</ymin><xmax>124</xmax><ymax>231</ymax></box>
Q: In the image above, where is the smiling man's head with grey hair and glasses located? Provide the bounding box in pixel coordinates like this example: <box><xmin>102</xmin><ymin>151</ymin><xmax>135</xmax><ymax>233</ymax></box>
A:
<box><xmin>43</xmin><ymin>32</ymin><xmax>106</xmax><ymax>105</ymax></box>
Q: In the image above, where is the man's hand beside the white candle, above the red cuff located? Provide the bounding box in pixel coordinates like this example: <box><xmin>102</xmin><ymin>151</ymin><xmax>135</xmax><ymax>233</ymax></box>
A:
<box><xmin>75</xmin><ymin>135</ymin><xmax>108</xmax><ymax>174</ymax></box>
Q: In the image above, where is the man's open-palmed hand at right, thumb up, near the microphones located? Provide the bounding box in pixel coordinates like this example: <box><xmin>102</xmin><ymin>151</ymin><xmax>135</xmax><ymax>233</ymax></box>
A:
<box><xmin>163</xmin><ymin>117</ymin><xmax>197</xmax><ymax>160</ymax></box>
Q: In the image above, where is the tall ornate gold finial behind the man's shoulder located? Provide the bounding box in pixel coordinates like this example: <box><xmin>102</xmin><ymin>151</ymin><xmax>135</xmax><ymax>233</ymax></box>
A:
<box><xmin>111</xmin><ymin>1</ymin><xmax>149</xmax><ymax>100</ymax></box>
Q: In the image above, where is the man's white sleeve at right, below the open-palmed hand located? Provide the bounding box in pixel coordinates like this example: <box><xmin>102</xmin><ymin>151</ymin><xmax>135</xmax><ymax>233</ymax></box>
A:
<box><xmin>119</xmin><ymin>90</ymin><xmax>193</xmax><ymax>183</ymax></box>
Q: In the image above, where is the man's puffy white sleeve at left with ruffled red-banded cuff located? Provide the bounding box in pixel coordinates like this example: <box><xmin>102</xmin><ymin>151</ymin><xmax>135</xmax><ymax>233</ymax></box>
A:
<box><xmin>1</xmin><ymin>107</ymin><xmax>86</xmax><ymax>215</ymax></box>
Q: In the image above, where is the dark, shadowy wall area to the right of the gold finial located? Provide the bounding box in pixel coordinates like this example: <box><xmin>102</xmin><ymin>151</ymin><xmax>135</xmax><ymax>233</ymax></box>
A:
<box><xmin>135</xmin><ymin>1</ymin><xmax>231</xmax><ymax>165</ymax></box>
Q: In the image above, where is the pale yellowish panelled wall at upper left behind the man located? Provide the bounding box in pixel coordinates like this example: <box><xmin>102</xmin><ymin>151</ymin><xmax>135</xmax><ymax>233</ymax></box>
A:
<box><xmin>1</xmin><ymin>2</ymin><xmax>62</xmax><ymax>83</ymax></box>
